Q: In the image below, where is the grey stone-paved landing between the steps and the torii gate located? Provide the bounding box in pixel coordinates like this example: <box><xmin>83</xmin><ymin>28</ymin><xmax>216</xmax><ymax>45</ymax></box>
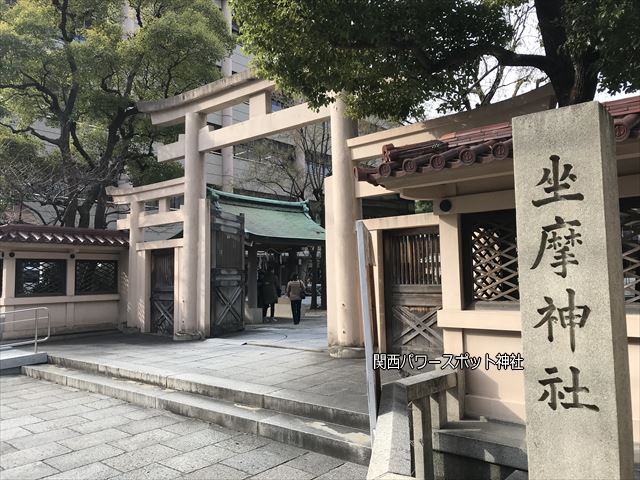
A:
<box><xmin>37</xmin><ymin>318</ymin><xmax>397</xmax><ymax>412</ymax></box>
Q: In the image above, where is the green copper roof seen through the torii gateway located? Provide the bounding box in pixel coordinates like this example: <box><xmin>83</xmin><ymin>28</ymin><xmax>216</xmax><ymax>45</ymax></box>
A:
<box><xmin>207</xmin><ymin>188</ymin><xmax>324</xmax><ymax>244</ymax></box>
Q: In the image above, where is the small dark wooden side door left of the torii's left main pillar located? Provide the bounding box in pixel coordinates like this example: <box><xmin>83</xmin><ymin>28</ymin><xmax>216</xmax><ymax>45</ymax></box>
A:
<box><xmin>151</xmin><ymin>249</ymin><xmax>174</xmax><ymax>336</ymax></box>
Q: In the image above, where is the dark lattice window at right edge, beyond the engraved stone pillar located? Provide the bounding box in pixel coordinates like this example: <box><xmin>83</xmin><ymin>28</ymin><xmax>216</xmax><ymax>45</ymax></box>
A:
<box><xmin>620</xmin><ymin>198</ymin><xmax>640</xmax><ymax>304</ymax></box>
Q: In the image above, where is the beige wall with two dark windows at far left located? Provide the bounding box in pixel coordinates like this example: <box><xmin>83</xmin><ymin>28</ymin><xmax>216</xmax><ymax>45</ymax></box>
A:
<box><xmin>0</xmin><ymin>236</ymin><xmax>127</xmax><ymax>343</ymax></box>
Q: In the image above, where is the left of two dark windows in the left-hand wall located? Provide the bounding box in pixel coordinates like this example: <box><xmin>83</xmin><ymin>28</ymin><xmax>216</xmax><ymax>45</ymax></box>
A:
<box><xmin>16</xmin><ymin>258</ymin><xmax>67</xmax><ymax>297</ymax></box>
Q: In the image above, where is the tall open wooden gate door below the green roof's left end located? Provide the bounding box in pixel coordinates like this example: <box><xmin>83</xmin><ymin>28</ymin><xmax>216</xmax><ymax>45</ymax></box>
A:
<box><xmin>211</xmin><ymin>208</ymin><xmax>244</xmax><ymax>336</ymax></box>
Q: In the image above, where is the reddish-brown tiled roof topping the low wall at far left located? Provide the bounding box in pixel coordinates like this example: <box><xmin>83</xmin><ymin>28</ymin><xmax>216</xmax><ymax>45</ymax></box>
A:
<box><xmin>0</xmin><ymin>224</ymin><xmax>129</xmax><ymax>247</ymax></box>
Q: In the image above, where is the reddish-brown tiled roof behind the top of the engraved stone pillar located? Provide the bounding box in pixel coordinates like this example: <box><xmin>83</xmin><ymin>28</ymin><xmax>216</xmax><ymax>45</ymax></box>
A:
<box><xmin>356</xmin><ymin>96</ymin><xmax>640</xmax><ymax>185</ymax></box>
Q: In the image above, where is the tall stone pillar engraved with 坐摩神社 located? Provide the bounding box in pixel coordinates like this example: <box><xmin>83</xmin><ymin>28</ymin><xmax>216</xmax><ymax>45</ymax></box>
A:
<box><xmin>513</xmin><ymin>102</ymin><xmax>633</xmax><ymax>480</ymax></box>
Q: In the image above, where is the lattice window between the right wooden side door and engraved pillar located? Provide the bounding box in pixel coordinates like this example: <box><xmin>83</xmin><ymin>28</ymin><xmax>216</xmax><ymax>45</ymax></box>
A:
<box><xmin>463</xmin><ymin>210</ymin><xmax>520</xmax><ymax>302</ymax></box>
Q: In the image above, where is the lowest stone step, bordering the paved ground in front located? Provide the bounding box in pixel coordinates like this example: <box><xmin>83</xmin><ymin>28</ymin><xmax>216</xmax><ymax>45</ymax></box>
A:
<box><xmin>22</xmin><ymin>364</ymin><xmax>371</xmax><ymax>465</ymax></box>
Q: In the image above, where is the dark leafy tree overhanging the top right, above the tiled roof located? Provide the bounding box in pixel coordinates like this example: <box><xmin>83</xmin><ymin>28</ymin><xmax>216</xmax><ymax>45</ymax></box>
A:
<box><xmin>233</xmin><ymin>0</ymin><xmax>640</xmax><ymax>119</ymax></box>
